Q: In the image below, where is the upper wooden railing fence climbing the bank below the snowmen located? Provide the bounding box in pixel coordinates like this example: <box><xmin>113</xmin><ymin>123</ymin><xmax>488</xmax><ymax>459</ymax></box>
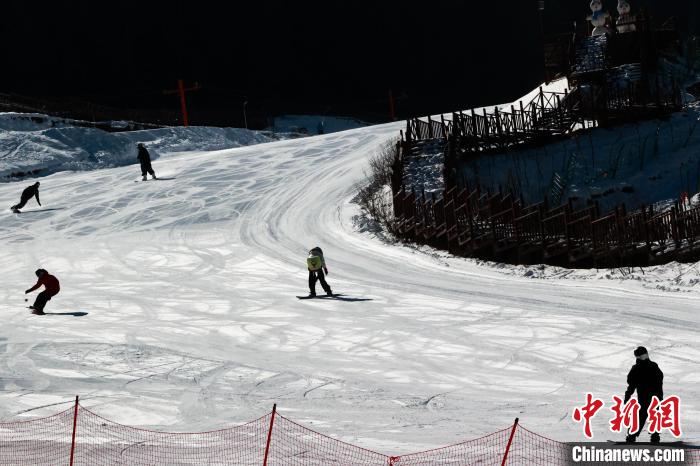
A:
<box><xmin>402</xmin><ymin>79</ymin><xmax>682</xmax><ymax>156</ymax></box>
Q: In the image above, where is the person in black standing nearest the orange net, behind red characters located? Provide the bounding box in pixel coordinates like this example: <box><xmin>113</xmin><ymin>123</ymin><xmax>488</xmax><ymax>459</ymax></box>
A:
<box><xmin>625</xmin><ymin>346</ymin><xmax>664</xmax><ymax>443</ymax></box>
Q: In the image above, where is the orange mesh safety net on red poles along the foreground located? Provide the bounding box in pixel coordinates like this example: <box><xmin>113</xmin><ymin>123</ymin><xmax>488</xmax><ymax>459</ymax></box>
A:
<box><xmin>0</xmin><ymin>404</ymin><xmax>700</xmax><ymax>466</ymax></box>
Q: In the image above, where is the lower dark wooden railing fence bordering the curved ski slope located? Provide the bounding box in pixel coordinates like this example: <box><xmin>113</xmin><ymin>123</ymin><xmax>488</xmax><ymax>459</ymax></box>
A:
<box><xmin>394</xmin><ymin>184</ymin><xmax>700</xmax><ymax>268</ymax></box>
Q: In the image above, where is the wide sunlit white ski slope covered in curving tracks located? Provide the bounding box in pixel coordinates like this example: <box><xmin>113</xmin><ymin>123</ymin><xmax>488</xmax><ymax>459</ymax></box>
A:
<box><xmin>0</xmin><ymin>90</ymin><xmax>700</xmax><ymax>454</ymax></box>
